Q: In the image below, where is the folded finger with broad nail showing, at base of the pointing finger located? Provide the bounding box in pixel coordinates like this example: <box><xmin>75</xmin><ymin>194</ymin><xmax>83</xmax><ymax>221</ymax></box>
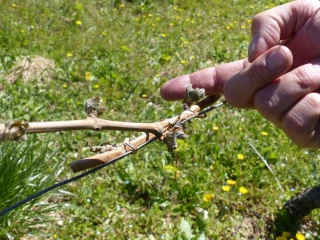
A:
<box><xmin>224</xmin><ymin>46</ymin><xmax>293</xmax><ymax>108</ymax></box>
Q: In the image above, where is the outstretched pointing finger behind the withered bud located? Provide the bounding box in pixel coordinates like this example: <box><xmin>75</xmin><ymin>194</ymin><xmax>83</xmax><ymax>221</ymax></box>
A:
<box><xmin>160</xmin><ymin>59</ymin><xmax>247</xmax><ymax>101</ymax></box>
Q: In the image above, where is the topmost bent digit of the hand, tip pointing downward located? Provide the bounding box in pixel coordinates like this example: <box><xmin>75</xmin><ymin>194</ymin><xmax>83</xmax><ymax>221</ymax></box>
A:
<box><xmin>248</xmin><ymin>0</ymin><xmax>320</xmax><ymax>62</ymax></box>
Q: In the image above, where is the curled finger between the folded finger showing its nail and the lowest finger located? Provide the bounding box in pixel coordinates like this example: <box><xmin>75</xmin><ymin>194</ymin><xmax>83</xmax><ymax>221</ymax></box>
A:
<box><xmin>254</xmin><ymin>59</ymin><xmax>320</xmax><ymax>127</ymax></box>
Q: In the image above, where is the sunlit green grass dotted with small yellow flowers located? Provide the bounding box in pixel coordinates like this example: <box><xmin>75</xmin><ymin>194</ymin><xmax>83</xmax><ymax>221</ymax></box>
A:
<box><xmin>0</xmin><ymin>0</ymin><xmax>320</xmax><ymax>240</ymax></box>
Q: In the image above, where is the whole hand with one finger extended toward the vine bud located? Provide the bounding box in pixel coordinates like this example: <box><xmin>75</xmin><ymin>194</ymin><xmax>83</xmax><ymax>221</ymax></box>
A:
<box><xmin>160</xmin><ymin>0</ymin><xmax>320</xmax><ymax>148</ymax></box>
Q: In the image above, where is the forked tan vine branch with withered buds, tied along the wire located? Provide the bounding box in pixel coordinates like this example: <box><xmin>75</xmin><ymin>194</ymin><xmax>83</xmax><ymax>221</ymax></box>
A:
<box><xmin>0</xmin><ymin>85</ymin><xmax>224</xmax><ymax>172</ymax></box>
